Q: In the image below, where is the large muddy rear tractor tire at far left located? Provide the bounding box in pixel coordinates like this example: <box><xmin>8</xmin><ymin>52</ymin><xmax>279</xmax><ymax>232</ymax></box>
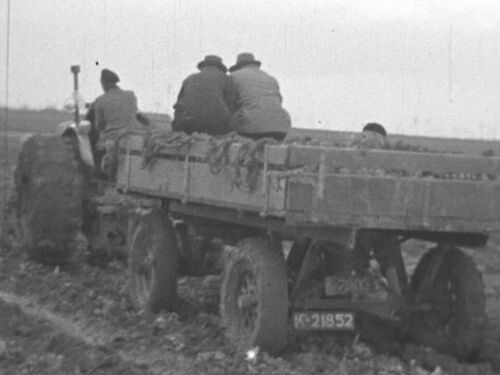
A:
<box><xmin>14</xmin><ymin>135</ymin><xmax>86</xmax><ymax>265</ymax></box>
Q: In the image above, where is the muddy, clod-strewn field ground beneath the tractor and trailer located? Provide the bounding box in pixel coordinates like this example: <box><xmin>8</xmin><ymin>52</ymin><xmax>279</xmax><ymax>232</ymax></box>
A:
<box><xmin>0</xmin><ymin>241</ymin><xmax>500</xmax><ymax>375</ymax></box>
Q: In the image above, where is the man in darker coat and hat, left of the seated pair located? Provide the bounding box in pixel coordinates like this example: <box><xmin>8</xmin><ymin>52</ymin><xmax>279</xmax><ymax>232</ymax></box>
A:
<box><xmin>172</xmin><ymin>55</ymin><xmax>234</xmax><ymax>135</ymax></box>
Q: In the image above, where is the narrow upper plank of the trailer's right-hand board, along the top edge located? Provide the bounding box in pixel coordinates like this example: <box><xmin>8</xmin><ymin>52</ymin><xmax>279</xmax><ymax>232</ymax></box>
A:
<box><xmin>288</xmin><ymin>146</ymin><xmax>500</xmax><ymax>176</ymax></box>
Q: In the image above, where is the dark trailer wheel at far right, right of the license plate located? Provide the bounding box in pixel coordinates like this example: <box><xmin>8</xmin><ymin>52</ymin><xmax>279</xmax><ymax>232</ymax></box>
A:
<box><xmin>407</xmin><ymin>246</ymin><xmax>486</xmax><ymax>360</ymax></box>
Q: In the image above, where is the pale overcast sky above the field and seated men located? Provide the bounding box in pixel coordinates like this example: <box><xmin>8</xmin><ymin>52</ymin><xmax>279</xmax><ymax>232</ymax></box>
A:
<box><xmin>0</xmin><ymin>0</ymin><xmax>500</xmax><ymax>138</ymax></box>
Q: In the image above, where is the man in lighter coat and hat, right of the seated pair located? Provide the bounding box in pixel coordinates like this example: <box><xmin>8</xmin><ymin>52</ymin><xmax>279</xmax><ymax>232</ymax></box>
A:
<box><xmin>229</xmin><ymin>53</ymin><xmax>291</xmax><ymax>141</ymax></box>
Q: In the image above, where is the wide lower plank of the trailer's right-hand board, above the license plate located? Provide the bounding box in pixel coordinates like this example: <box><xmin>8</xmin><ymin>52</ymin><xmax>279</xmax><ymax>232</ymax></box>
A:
<box><xmin>286</xmin><ymin>175</ymin><xmax>500</xmax><ymax>232</ymax></box>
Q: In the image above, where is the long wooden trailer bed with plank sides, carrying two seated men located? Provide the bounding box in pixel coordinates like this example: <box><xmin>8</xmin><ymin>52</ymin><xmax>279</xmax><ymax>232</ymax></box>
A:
<box><xmin>118</xmin><ymin>135</ymin><xmax>500</xmax><ymax>233</ymax></box>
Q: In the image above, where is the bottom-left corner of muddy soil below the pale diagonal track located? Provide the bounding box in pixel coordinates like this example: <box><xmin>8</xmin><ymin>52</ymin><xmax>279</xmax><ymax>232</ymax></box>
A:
<box><xmin>0</xmin><ymin>300</ymin><xmax>144</xmax><ymax>375</ymax></box>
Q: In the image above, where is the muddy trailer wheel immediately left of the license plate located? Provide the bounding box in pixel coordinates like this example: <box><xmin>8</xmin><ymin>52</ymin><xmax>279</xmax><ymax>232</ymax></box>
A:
<box><xmin>221</xmin><ymin>238</ymin><xmax>288</xmax><ymax>352</ymax></box>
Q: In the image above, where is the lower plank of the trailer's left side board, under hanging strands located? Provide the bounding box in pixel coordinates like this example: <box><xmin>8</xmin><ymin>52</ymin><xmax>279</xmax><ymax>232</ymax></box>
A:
<box><xmin>118</xmin><ymin>155</ymin><xmax>285</xmax><ymax>214</ymax></box>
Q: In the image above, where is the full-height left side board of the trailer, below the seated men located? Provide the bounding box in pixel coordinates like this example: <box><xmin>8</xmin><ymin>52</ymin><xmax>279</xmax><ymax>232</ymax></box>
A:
<box><xmin>117</xmin><ymin>136</ymin><xmax>285</xmax><ymax>216</ymax></box>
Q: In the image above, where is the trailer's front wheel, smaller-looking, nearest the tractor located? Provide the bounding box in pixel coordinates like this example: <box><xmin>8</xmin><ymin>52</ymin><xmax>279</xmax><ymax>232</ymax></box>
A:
<box><xmin>128</xmin><ymin>211</ymin><xmax>178</xmax><ymax>312</ymax></box>
